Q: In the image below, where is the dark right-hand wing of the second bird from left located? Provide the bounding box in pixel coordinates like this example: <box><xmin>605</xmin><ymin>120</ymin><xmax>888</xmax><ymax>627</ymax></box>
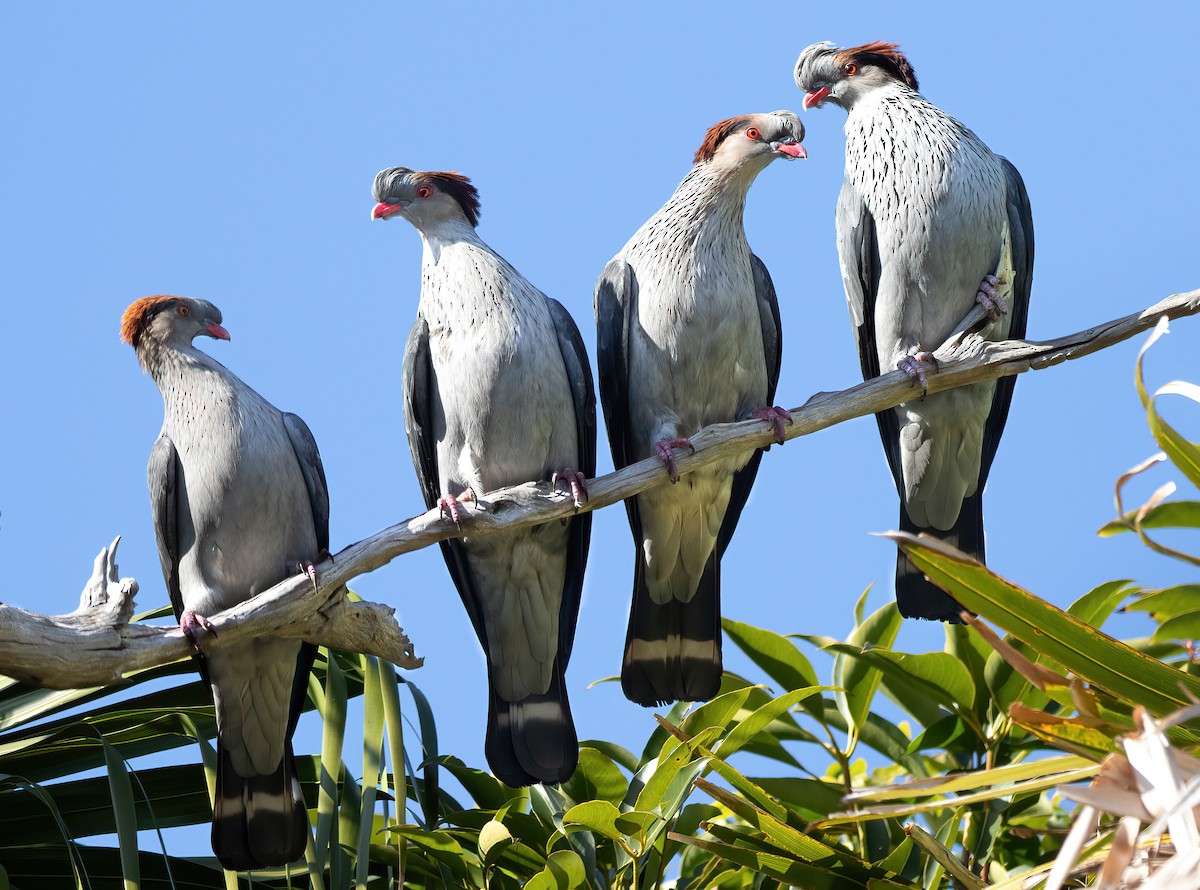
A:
<box><xmin>546</xmin><ymin>297</ymin><xmax>596</xmax><ymax>668</ymax></box>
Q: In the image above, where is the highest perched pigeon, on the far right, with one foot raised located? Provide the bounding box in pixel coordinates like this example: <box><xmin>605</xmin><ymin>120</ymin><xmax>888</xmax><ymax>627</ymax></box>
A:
<box><xmin>796</xmin><ymin>42</ymin><xmax>1033</xmax><ymax>621</ymax></box>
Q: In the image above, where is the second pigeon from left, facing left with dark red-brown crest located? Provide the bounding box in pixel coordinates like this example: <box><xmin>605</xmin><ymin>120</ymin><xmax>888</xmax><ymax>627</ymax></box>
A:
<box><xmin>372</xmin><ymin>167</ymin><xmax>595</xmax><ymax>787</ymax></box>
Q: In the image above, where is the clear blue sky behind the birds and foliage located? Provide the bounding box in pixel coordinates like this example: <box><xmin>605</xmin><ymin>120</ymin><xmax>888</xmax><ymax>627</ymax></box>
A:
<box><xmin>0</xmin><ymin>2</ymin><xmax>1200</xmax><ymax>852</ymax></box>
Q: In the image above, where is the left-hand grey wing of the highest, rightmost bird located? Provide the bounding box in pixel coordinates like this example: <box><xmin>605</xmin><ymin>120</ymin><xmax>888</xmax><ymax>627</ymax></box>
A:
<box><xmin>836</xmin><ymin>182</ymin><xmax>904</xmax><ymax>500</ymax></box>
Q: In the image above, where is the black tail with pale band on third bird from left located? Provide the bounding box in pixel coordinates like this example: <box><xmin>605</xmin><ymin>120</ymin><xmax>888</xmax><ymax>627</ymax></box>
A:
<box><xmin>620</xmin><ymin>549</ymin><xmax>722</xmax><ymax>708</ymax></box>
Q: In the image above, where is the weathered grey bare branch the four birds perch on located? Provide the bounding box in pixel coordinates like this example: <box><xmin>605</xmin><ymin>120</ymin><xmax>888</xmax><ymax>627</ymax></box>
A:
<box><xmin>0</xmin><ymin>290</ymin><xmax>1200</xmax><ymax>687</ymax></box>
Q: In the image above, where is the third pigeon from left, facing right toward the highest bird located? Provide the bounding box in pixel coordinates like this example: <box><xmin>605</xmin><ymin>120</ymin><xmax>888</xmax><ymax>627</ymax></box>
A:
<box><xmin>595</xmin><ymin>112</ymin><xmax>806</xmax><ymax>705</ymax></box>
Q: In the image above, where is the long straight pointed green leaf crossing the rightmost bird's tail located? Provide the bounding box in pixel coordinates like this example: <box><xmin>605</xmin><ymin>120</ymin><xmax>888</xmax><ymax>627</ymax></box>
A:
<box><xmin>889</xmin><ymin>533</ymin><xmax>1200</xmax><ymax>716</ymax></box>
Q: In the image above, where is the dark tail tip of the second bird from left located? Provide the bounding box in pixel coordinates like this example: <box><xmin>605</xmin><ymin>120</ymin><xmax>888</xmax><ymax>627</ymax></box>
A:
<box><xmin>484</xmin><ymin>662</ymin><xmax>580</xmax><ymax>788</ymax></box>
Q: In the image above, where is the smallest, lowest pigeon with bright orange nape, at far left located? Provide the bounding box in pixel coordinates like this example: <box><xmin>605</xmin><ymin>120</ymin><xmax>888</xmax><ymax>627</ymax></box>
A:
<box><xmin>121</xmin><ymin>296</ymin><xmax>329</xmax><ymax>871</ymax></box>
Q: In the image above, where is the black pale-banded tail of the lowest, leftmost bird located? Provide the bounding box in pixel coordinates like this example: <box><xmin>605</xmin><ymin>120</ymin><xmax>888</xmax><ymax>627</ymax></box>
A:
<box><xmin>212</xmin><ymin>739</ymin><xmax>308</xmax><ymax>871</ymax></box>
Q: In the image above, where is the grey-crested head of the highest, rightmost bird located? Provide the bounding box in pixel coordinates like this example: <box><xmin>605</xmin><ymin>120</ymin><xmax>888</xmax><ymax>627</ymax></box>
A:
<box><xmin>796</xmin><ymin>41</ymin><xmax>917</xmax><ymax>110</ymax></box>
